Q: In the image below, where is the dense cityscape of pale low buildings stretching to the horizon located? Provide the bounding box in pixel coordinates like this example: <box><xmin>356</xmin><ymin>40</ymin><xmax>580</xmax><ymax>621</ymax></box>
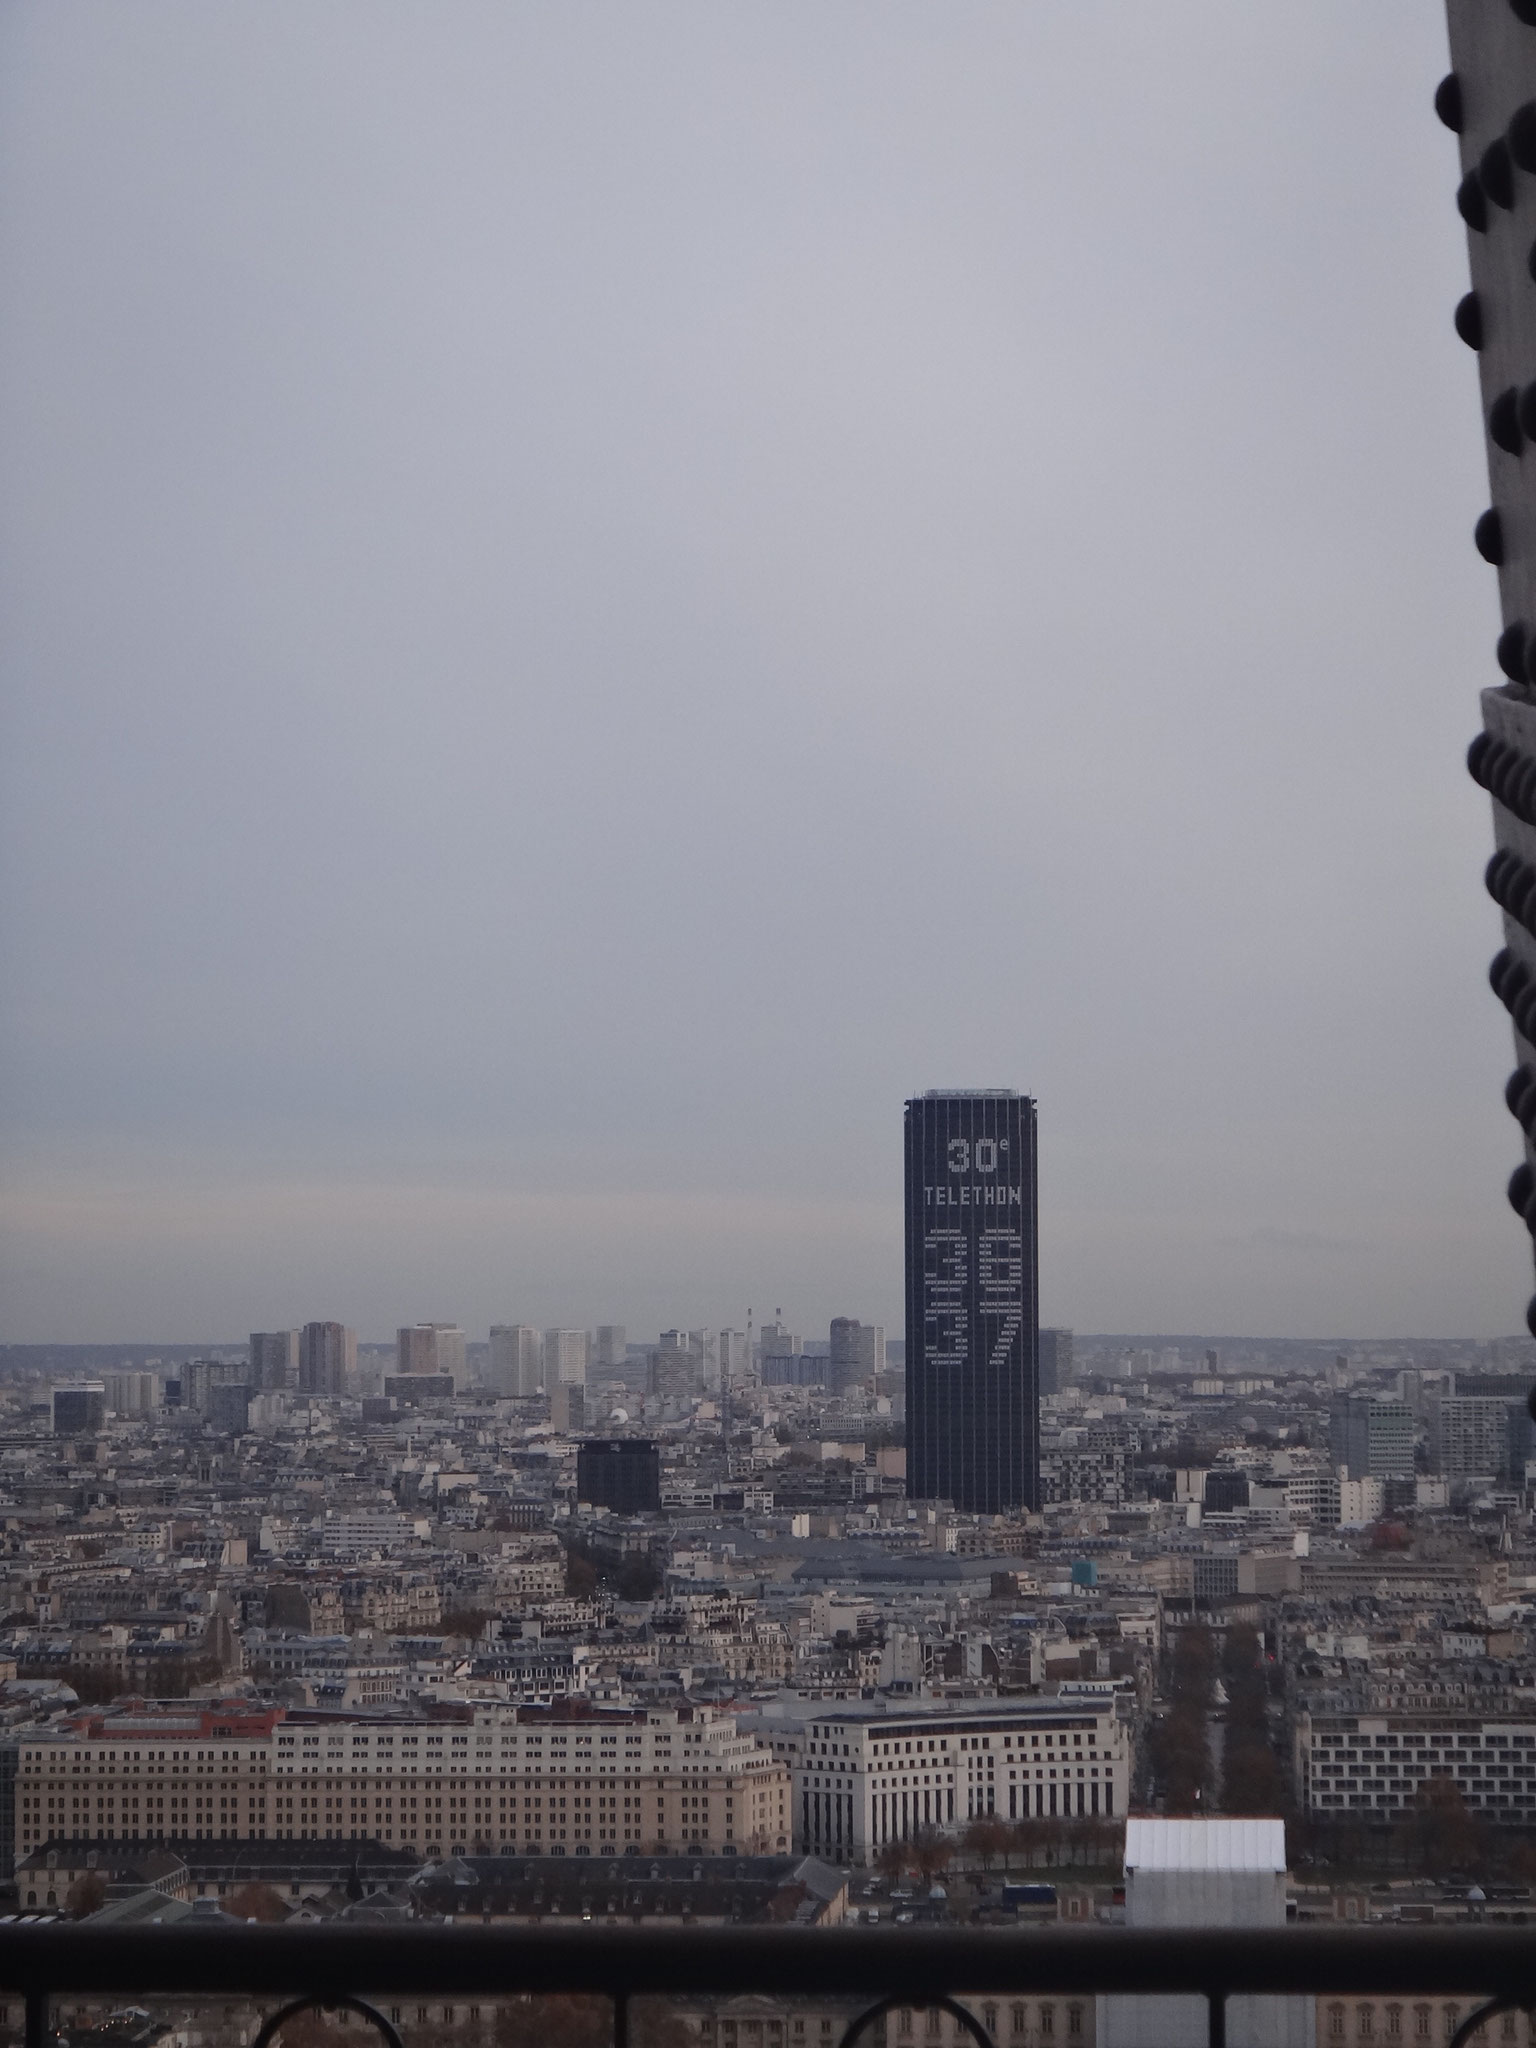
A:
<box><xmin>0</xmin><ymin>1179</ymin><xmax>1536</xmax><ymax>2025</ymax></box>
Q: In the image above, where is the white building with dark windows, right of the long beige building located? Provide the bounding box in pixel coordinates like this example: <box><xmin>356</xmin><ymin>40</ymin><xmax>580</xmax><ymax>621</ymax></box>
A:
<box><xmin>770</xmin><ymin>1696</ymin><xmax>1130</xmax><ymax>1864</ymax></box>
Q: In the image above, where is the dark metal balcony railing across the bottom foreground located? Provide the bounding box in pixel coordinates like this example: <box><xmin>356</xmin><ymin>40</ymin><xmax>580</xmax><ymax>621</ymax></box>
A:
<box><xmin>0</xmin><ymin>1923</ymin><xmax>1536</xmax><ymax>2048</ymax></box>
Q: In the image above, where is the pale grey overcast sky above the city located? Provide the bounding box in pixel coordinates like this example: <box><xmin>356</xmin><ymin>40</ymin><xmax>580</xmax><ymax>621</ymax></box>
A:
<box><xmin>0</xmin><ymin>0</ymin><xmax>1530</xmax><ymax>1341</ymax></box>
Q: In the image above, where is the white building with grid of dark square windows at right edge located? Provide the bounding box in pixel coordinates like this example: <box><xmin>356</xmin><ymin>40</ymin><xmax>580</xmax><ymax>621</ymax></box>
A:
<box><xmin>1296</xmin><ymin>1710</ymin><xmax>1536</xmax><ymax>1827</ymax></box>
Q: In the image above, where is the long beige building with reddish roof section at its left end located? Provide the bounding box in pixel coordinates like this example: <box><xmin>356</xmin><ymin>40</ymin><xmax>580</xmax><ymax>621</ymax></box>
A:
<box><xmin>14</xmin><ymin>1702</ymin><xmax>791</xmax><ymax>1858</ymax></box>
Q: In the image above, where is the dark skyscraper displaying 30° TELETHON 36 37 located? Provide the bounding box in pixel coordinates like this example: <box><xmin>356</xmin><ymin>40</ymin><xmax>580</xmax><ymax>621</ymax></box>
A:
<box><xmin>907</xmin><ymin>1087</ymin><xmax>1040</xmax><ymax>1513</ymax></box>
